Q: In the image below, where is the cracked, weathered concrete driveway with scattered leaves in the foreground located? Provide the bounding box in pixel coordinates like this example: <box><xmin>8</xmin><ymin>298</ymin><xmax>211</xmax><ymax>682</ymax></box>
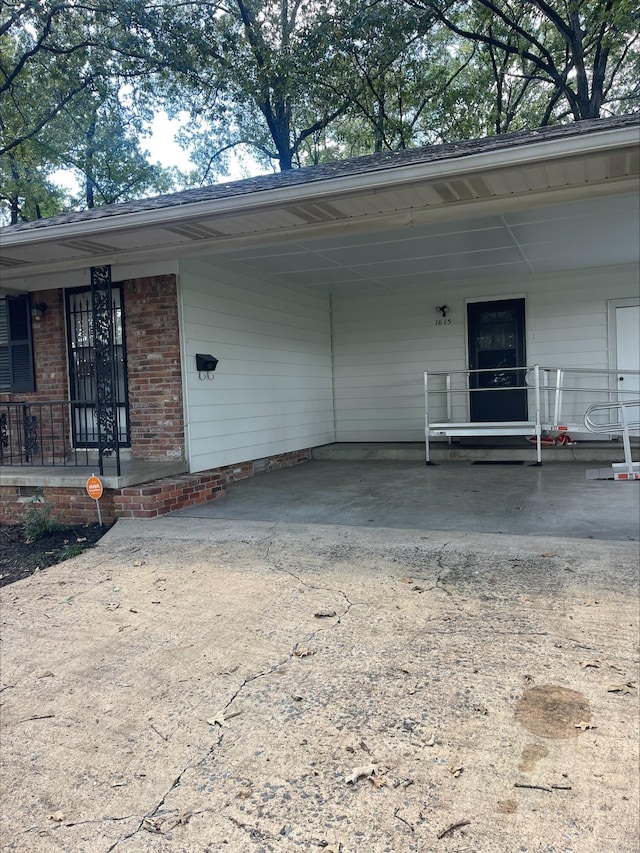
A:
<box><xmin>0</xmin><ymin>492</ymin><xmax>639</xmax><ymax>853</ymax></box>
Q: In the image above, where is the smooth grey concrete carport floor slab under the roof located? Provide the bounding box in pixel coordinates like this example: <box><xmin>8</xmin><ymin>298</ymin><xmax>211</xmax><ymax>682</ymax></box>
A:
<box><xmin>174</xmin><ymin>460</ymin><xmax>640</xmax><ymax>540</ymax></box>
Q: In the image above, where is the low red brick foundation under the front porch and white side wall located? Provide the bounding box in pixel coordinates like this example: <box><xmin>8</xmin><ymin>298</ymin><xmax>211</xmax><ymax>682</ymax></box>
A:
<box><xmin>0</xmin><ymin>449</ymin><xmax>311</xmax><ymax>525</ymax></box>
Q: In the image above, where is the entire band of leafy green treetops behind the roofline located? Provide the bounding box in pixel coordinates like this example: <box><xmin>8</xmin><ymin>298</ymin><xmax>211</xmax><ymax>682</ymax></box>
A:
<box><xmin>0</xmin><ymin>0</ymin><xmax>640</xmax><ymax>222</ymax></box>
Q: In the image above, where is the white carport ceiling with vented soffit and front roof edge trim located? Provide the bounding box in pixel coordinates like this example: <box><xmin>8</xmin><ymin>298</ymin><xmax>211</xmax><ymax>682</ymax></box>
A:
<box><xmin>0</xmin><ymin>120</ymin><xmax>640</xmax><ymax>291</ymax></box>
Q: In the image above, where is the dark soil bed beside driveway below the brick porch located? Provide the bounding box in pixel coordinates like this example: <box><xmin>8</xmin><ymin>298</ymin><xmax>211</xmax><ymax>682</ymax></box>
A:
<box><xmin>0</xmin><ymin>523</ymin><xmax>109</xmax><ymax>586</ymax></box>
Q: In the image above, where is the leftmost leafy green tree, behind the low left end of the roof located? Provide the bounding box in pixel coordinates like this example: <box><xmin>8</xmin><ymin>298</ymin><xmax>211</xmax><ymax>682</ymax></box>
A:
<box><xmin>0</xmin><ymin>0</ymin><xmax>178</xmax><ymax>223</ymax></box>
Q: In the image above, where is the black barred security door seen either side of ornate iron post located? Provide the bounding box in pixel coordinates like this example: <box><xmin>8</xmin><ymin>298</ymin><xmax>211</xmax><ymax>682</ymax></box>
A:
<box><xmin>67</xmin><ymin>284</ymin><xmax>129</xmax><ymax>447</ymax></box>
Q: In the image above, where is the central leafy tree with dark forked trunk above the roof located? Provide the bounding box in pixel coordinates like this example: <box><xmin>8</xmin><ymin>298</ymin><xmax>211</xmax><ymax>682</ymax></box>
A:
<box><xmin>149</xmin><ymin>0</ymin><xmax>430</xmax><ymax>176</ymax></box>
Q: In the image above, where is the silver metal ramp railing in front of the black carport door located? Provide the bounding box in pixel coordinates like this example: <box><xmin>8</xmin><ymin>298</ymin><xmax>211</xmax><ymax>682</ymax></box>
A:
<box><xmin>424</xmin><ymin>364</ymin><xmax>640</xmax><ymax>465</ymax></box>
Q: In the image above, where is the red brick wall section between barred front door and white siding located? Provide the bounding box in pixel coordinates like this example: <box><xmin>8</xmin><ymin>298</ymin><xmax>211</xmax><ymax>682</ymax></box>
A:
<box><xmin>124</xmin><ymin>275</ymin><xmax>184</xmax><ymax>461</ymax></box>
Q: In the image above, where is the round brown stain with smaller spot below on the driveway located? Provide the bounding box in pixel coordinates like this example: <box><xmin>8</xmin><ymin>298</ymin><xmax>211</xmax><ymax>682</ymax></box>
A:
<box><xmin>516</xmin><ymin>684</ymin><xmax>591</xmax><ymax>736</ymax></box>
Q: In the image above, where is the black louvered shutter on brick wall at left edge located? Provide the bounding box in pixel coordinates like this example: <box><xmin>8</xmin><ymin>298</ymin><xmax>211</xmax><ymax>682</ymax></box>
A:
<box><xmin>0</xmin><ymin>294</ymin><xmax>36</xmax><ymax>394</ymax></box>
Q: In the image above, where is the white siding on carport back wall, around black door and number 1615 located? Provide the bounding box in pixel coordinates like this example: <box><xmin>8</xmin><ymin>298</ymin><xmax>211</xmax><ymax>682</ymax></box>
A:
<box><xmin>333</xmin><ymin>266</ymin><xmax>638</xmax><ymax>441</ymax></box>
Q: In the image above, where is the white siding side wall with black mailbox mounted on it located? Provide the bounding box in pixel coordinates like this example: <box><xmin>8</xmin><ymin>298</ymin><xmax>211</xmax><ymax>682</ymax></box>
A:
<box><xmin>180</xmin><ymin>259</ymin><xmax>335</xmax><ymax>471</ymax></box>
